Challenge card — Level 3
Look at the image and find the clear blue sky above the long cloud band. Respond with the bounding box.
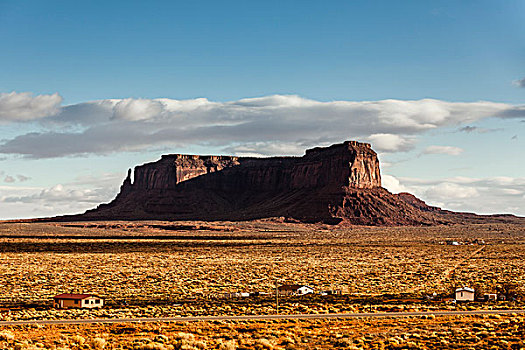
[0,0,525,103]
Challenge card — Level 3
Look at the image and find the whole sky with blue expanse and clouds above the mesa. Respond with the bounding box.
[0,0,525,219]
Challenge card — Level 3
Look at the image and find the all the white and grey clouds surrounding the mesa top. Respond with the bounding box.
[0,92,525,218]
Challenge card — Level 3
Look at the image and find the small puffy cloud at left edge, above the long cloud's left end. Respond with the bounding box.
[0,91,62,122]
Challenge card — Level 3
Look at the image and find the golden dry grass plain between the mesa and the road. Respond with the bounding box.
[0,221,525,319]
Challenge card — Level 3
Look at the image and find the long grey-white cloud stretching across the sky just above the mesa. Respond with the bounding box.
[0,95,525,158]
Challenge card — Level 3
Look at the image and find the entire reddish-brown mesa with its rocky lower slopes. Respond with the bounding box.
[71,141,516,225]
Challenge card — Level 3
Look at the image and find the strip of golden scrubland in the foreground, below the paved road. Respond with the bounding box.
[0,315,525,350]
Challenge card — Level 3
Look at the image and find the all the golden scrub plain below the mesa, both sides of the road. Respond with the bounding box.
[0,220,525,349]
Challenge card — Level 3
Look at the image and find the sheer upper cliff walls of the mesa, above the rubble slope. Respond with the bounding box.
[127,141,381,191]
